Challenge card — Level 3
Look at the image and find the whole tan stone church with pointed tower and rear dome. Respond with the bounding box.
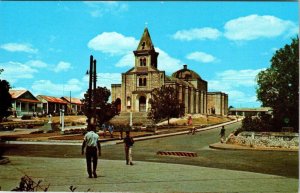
[111,28,228,115]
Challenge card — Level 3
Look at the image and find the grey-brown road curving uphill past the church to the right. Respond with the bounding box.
[1,122,299,178]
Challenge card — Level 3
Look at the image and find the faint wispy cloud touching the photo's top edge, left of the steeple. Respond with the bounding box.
[84,1,128,18]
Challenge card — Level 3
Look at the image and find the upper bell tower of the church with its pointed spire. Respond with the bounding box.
[133,28,158,69]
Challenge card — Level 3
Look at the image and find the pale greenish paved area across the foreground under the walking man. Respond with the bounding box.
[0,156,298,193]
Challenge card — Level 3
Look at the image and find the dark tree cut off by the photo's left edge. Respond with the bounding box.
[0,69,12,122]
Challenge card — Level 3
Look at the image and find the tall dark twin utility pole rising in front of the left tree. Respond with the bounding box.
[86,55,97,129]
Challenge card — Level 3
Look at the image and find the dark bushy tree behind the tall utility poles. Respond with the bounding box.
[81,87,117,125]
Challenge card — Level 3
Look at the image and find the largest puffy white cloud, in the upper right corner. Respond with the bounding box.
[224,15,298,40]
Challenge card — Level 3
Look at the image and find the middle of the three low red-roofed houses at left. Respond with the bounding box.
[37,95,68,115]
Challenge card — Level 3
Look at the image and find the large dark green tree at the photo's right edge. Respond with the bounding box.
[256,37,299,131]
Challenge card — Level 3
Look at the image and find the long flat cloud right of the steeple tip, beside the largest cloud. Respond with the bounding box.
[172,27,222,41]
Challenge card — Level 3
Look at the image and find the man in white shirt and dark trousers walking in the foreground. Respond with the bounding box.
[81,125,101,178]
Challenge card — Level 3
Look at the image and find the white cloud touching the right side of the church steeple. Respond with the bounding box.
[155,48,184,74]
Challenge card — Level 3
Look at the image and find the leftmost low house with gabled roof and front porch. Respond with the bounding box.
[9,89,42,117]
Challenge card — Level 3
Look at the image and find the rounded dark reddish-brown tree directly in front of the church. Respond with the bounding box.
[148,86,184,125]
